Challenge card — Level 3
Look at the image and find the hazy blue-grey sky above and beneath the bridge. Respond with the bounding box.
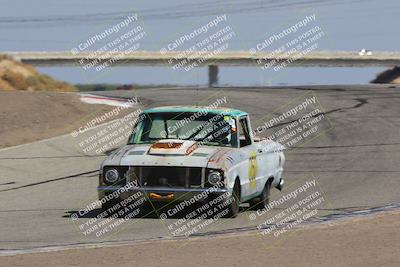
[0,0,400,85]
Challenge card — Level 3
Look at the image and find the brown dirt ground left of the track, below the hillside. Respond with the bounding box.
[0,91,113,148]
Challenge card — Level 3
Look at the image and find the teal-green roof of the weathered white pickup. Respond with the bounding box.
[143,106,247,117]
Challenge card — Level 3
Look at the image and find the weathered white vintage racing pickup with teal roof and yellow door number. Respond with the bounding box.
[97,106,285,217]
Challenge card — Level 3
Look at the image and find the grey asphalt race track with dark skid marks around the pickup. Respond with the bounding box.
[0,85,400,252]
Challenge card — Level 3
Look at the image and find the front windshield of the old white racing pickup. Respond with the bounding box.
[128,112,237,147]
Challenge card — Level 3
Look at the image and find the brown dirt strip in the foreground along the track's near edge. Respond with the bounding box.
[0,212,400,267]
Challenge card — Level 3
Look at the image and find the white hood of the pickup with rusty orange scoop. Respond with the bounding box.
[103,140,232,168]
